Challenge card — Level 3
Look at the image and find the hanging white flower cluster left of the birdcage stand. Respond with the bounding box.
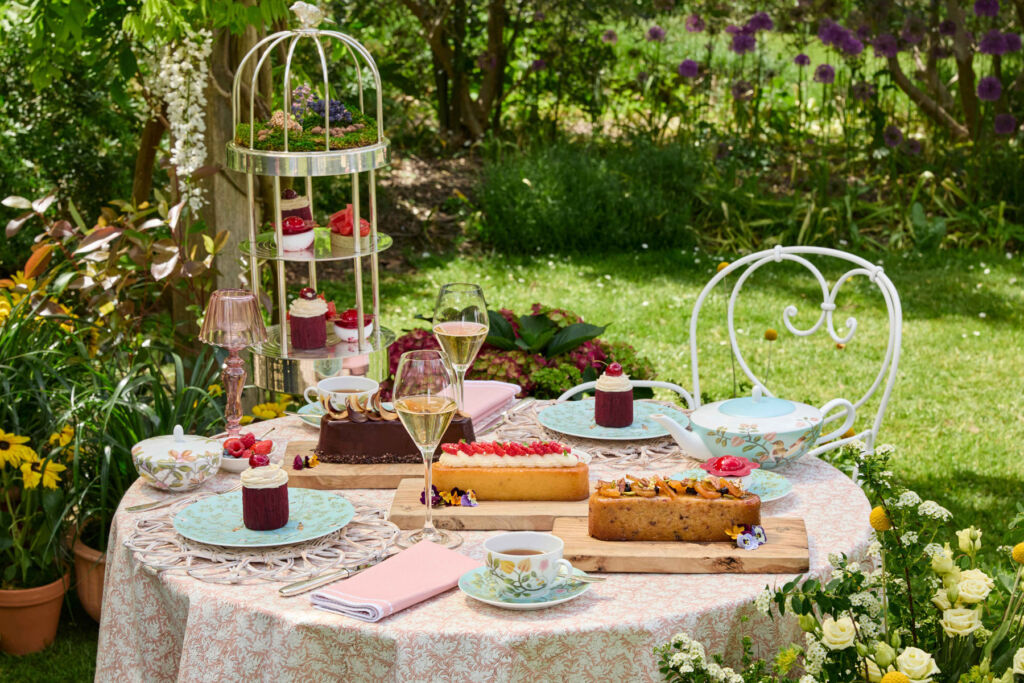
[150,30,213,213]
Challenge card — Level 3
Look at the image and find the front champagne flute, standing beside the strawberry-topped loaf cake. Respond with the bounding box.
[393,350,462,548]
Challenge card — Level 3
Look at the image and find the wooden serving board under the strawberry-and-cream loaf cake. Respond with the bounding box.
[388,477,589,531]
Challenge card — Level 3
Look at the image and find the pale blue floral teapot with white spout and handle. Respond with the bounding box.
[650,385,856,469]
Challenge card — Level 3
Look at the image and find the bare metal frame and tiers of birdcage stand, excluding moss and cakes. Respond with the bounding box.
[227,17,394,394]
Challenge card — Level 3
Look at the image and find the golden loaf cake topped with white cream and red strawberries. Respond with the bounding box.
[433,441,590,501]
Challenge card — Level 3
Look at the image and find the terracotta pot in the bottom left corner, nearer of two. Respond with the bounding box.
[0,573,71,654]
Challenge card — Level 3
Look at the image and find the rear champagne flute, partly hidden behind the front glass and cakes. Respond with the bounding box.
[434,283,490,413]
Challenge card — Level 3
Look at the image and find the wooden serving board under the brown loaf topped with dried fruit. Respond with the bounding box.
[551,517,810,573]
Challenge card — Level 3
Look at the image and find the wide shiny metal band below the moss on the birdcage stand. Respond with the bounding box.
[227,137,391,178]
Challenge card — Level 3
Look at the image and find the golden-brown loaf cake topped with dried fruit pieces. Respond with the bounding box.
[590,476,761,541]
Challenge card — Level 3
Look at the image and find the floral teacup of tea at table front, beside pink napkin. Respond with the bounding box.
[483,531,572,598]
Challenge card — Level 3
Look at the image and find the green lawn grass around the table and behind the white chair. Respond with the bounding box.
[9,250,1024,681]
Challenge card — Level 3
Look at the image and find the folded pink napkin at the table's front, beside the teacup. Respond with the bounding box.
[312,541,482,622]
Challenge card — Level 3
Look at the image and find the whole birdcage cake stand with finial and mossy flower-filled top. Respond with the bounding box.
[227,3,394,394]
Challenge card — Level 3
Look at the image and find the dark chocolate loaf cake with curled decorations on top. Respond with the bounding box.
[315,393,475,465]
